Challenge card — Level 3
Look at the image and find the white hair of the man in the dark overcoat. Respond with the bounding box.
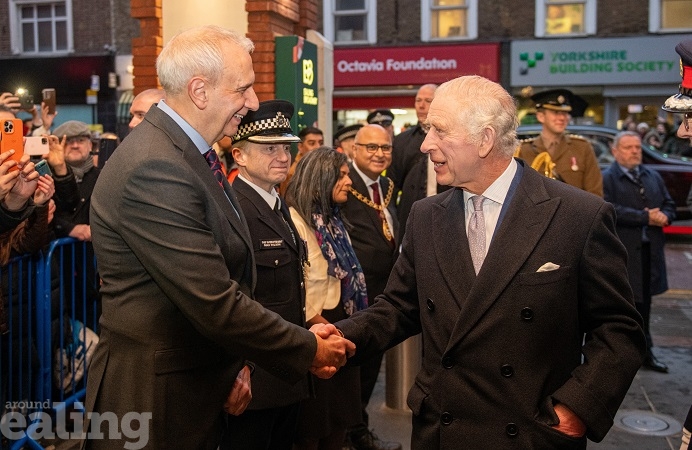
[435,75,519,157]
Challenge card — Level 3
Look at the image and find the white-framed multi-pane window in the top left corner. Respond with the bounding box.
[10,0,72,55]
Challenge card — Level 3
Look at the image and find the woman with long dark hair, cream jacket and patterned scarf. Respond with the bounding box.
[286,147,368,450]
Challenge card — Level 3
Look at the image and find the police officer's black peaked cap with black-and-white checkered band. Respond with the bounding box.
[233,100,300,144]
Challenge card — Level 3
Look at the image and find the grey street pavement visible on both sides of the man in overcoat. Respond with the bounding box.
[368,235,692,450]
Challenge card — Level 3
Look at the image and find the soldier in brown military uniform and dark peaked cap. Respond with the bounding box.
[517,89,603,197]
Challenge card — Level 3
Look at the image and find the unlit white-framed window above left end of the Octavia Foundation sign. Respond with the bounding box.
[323,0,377,44]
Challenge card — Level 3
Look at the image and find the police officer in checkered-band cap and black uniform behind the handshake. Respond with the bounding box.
[220,100,309,450]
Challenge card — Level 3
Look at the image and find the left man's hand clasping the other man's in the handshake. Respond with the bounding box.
[310,324,356,379]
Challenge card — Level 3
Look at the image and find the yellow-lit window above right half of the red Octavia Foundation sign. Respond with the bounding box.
[421,0,478,42]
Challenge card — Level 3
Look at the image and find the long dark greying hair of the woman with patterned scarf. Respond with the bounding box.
[286,146,348,226]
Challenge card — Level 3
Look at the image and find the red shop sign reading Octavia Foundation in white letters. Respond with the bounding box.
[334,44,500,87]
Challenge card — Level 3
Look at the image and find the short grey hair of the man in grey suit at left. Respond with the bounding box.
[156,25,255,95]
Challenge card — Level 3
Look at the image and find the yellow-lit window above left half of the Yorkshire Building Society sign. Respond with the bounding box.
[536,0,596,37]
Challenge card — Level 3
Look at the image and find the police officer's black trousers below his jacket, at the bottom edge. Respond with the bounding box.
[219,403,300,450]
